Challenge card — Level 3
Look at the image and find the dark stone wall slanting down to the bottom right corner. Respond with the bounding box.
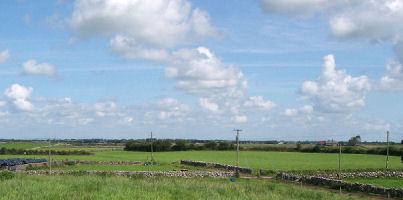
[277,172,403,198]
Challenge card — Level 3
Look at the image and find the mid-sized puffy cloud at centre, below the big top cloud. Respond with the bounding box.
[165,47,247,96]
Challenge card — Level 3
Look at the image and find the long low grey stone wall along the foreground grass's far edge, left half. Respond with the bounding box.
[25,170,235,178]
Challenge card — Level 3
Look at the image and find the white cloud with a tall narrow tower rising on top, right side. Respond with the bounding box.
[300,55,371,112]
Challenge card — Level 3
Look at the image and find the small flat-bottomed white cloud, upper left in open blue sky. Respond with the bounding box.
[21,59,56,77]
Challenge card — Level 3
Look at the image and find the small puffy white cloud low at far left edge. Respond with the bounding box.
[4,84,34,111]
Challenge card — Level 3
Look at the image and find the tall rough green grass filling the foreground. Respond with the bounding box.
[0,174,366,200]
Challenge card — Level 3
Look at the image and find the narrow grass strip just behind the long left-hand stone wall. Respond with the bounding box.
[53,164,221,171]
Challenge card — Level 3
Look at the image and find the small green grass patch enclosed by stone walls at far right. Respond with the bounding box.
[343,177,403,188]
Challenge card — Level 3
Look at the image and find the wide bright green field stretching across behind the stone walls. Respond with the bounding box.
[0,151,403,170]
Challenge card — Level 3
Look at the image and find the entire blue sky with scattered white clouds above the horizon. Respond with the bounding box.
[0,0,403,141]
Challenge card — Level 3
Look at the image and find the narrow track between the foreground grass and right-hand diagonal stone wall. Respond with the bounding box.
[241,176,393,199]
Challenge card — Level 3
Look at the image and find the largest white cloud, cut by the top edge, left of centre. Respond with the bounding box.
[69,0,218,59]
